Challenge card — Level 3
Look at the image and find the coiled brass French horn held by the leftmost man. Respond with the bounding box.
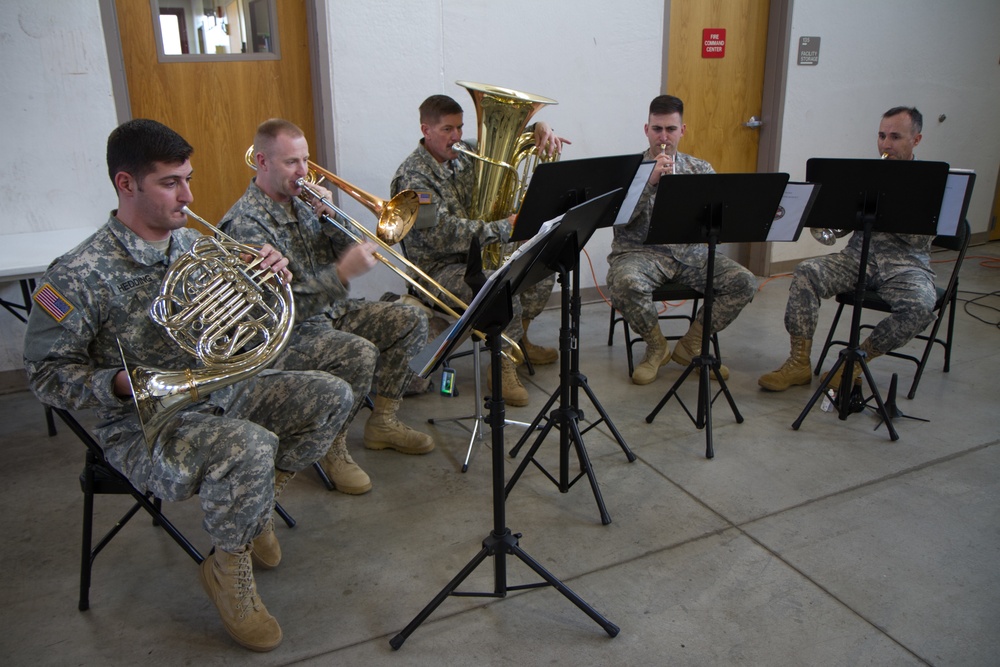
[118,207,295,447]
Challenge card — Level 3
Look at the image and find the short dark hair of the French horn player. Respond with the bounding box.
[107,118,194,192]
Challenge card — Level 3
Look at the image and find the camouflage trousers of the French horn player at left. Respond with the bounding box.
[104,370,350,551]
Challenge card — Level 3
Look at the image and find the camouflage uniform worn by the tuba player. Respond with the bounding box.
[391,140,555,348]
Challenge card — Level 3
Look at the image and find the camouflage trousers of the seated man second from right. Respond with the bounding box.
[607,253,757,335]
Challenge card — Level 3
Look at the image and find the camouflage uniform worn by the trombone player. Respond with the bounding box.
[221,181,427,424]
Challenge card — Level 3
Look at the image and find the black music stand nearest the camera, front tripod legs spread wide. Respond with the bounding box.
[389,215,620,649]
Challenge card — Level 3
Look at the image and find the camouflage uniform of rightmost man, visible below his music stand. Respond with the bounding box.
[785,232,937,354]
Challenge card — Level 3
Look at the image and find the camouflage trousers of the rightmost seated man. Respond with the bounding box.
[785,252,937,354]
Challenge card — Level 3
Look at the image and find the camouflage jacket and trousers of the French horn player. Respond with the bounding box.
[24,214,352,551]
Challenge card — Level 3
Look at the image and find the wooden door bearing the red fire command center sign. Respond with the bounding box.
[663,0,770,173]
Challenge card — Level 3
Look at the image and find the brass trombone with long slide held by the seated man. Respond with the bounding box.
[244,145,524,364]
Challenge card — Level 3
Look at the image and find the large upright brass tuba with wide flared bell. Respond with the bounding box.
[452,81,559,269]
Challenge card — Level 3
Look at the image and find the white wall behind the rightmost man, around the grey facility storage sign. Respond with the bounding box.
[771,0,1000,261]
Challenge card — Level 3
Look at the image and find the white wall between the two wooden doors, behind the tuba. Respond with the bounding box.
[321,0,664,298]
